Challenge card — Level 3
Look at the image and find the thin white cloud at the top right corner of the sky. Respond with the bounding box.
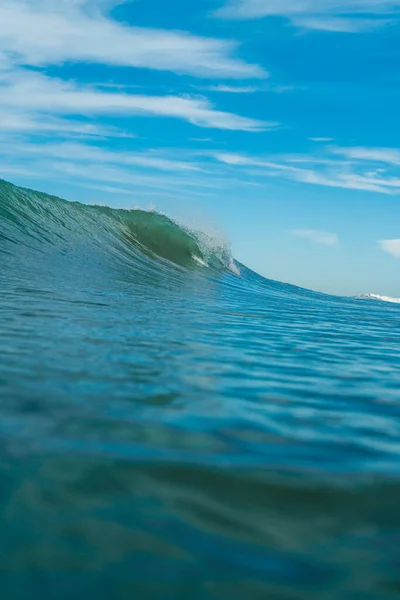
[218,0,400,32]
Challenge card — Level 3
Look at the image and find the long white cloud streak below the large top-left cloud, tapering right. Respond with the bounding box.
[0,69,268,131]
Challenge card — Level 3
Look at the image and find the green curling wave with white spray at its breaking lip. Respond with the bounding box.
[0,180,238,273]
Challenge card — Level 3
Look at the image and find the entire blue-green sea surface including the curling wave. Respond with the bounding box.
[0,182,400,600]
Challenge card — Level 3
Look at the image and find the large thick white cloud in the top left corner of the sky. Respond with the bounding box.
[0,0,265,79]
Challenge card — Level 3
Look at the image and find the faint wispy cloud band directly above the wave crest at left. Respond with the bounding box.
[0,138,260,204]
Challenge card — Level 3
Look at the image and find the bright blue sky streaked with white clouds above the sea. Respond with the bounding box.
[0,0,400,297]
